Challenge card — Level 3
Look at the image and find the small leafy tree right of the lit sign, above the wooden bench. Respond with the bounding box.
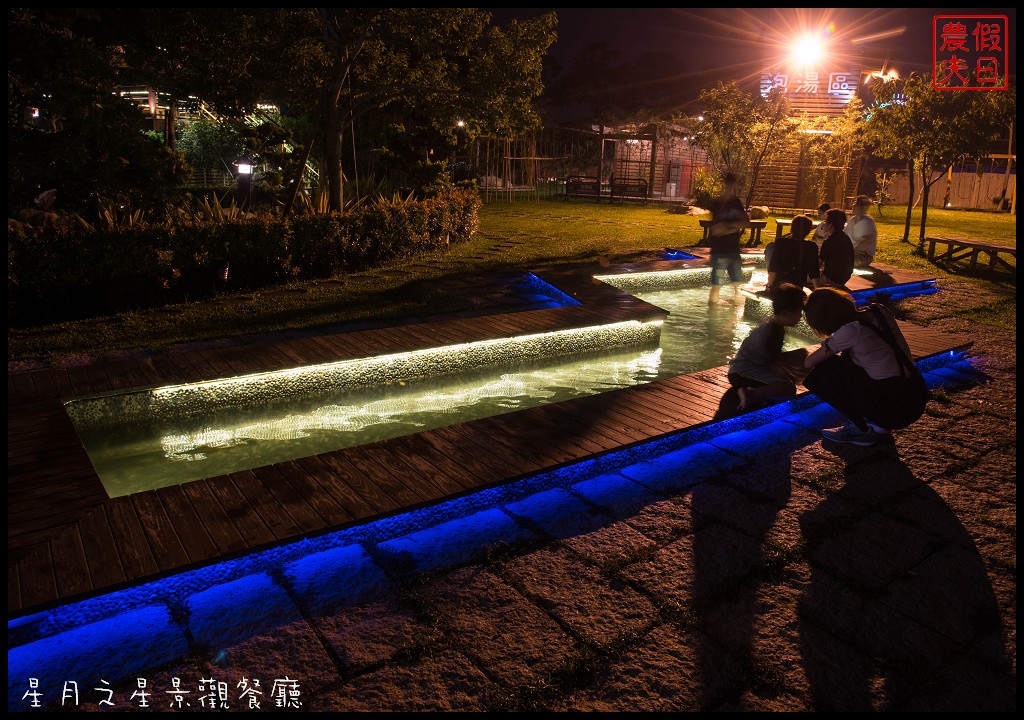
[867,75,1017,246]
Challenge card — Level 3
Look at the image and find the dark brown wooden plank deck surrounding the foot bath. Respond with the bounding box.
[7,260,970,618]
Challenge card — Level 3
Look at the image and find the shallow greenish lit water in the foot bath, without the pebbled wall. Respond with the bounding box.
[68,270,814,497]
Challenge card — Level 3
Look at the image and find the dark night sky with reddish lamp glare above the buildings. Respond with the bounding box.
[483,7,1017,79]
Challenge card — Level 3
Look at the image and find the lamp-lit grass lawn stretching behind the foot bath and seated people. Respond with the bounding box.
[7,200,1017,363]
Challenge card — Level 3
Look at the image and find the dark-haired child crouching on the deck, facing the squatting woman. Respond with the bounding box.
[729,283,805,410]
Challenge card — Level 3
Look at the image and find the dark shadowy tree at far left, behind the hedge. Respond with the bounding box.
[7,8,186,212]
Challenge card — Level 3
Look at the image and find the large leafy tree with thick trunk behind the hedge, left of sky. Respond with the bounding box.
[272,8,556,217]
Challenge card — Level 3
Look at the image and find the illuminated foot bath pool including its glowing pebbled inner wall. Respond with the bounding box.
[66,268,814,497]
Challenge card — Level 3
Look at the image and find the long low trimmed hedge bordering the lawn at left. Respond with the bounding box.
[7,188,481,327]
